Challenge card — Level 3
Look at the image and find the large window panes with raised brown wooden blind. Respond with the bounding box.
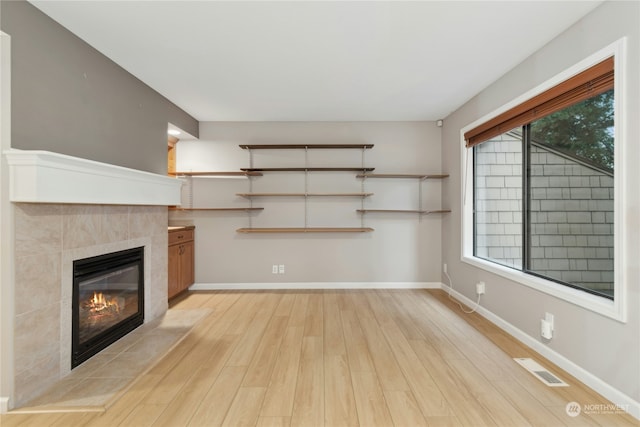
[464,57,616,310]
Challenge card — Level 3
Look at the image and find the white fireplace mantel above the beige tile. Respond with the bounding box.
[4,149,182,206]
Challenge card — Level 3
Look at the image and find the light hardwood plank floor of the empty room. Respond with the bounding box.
[0,290,639,427]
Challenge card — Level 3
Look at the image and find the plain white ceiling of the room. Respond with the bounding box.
[31,0,601,121]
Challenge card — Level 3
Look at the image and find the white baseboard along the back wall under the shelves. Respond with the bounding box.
[189,282,442,291]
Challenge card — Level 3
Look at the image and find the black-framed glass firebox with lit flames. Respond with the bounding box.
[71,247,144,369]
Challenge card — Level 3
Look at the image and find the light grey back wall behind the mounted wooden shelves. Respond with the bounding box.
[170,122,446,284]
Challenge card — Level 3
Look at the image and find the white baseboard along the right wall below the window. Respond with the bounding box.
[442,284,640,420]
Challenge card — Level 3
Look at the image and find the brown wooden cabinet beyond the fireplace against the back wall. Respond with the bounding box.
[168,226,195,298]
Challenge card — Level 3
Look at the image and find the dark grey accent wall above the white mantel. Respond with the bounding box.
[0,1,198,174]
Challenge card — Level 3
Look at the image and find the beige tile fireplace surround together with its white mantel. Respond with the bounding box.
[0,149,181,412]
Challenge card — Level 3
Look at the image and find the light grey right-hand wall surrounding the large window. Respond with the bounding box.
[442,2,640,417]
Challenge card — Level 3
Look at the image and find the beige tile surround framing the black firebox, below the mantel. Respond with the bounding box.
[13,203,167,406]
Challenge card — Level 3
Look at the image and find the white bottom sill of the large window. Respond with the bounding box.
[462,256,626,323]
